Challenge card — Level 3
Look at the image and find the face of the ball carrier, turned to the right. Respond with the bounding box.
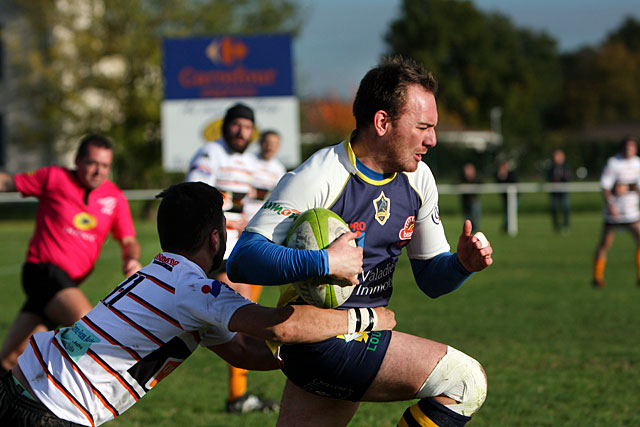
[384,85,438,173]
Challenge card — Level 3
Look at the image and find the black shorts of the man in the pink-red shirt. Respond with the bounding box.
[22,262,78,318]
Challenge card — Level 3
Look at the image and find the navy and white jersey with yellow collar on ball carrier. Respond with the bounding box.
[245,135,450,308]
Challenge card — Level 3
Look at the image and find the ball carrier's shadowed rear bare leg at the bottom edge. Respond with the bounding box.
[277,380,360,427]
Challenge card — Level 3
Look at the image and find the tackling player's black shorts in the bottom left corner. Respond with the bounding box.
[0,371,85,427]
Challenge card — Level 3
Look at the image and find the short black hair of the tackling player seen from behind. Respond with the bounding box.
[156,182,224,255]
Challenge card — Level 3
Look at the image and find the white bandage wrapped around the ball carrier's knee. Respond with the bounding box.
[416,347,487,416]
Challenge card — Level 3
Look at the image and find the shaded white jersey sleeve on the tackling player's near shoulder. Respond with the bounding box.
[176,278,254,347]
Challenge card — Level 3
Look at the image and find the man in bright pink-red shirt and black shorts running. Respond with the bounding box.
[0,135,141,370]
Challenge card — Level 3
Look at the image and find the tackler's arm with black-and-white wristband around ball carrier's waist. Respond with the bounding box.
[228,304,396,344]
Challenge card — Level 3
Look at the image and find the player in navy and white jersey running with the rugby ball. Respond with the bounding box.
[227,58,493,426]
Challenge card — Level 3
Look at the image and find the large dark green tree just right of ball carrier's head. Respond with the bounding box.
[386,0,561,143]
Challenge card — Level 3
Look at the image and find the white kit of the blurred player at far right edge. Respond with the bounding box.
[600,154,640,224]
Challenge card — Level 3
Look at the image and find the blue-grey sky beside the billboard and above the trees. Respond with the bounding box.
[294,0,640,99]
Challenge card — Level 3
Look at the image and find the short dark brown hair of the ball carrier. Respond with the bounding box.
[353,56,438,129]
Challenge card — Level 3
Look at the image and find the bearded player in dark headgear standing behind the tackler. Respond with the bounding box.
[186,103,278,413]
